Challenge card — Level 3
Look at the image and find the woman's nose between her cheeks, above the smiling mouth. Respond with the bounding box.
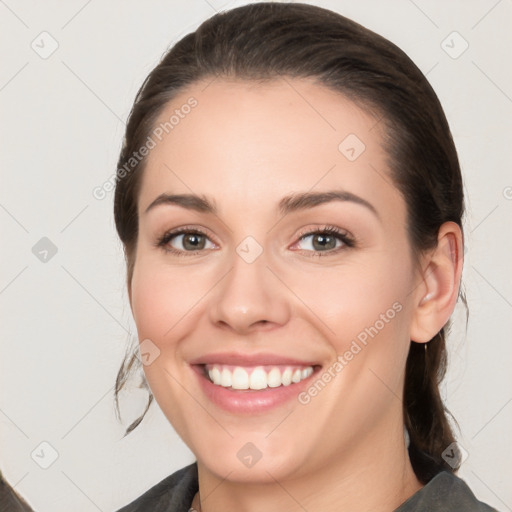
[210,248,290,334]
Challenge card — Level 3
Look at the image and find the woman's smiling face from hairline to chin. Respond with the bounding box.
[130,78,419,481]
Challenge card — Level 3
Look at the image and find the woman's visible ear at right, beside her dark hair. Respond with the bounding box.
[410,222,464,343]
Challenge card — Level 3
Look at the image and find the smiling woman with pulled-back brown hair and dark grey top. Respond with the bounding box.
[111,3,491,512]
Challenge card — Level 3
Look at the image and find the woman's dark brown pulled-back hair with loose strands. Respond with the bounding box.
[114,2,464,483]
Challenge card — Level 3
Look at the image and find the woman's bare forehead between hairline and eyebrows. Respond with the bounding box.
[139,78,400,220]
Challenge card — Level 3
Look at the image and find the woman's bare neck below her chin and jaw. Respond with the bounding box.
[194,427,422,512]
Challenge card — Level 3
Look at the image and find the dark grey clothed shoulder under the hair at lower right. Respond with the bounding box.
[395,471,496,512]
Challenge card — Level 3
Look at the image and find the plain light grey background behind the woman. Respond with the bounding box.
[0,0,512,512]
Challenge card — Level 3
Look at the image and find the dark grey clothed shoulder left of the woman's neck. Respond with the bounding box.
[117,462,198,512]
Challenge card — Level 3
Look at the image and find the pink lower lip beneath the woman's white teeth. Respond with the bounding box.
[193,365,317,414]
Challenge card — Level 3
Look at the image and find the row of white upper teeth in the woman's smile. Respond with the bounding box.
[207,364,313,390]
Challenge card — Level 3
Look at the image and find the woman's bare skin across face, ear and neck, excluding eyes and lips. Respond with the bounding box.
[129,78,462,512]
